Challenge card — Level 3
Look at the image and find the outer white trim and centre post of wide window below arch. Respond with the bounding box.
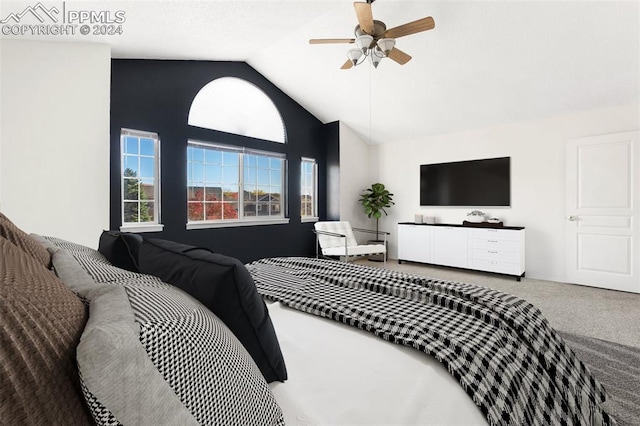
[186,139,289,226]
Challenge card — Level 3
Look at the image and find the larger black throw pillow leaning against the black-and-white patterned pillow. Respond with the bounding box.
[139,239,287,382]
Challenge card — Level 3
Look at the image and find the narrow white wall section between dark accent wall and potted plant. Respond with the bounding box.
[340,123,375,235]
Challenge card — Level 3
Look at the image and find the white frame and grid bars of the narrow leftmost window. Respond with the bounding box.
[120,128,164,232]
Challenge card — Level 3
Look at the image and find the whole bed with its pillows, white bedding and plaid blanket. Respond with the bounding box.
[0,214,615,425]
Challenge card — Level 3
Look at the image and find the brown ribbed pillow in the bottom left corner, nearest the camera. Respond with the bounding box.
[0,237,92,425]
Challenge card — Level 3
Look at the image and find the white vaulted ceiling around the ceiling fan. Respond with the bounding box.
[0,0,640,143]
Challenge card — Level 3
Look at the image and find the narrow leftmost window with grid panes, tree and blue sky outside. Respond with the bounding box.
[120,129,162,232]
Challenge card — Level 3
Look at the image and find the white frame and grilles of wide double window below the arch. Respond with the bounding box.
[186,139,289,230]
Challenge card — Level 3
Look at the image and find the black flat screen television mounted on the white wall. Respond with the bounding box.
[420,157,511,207]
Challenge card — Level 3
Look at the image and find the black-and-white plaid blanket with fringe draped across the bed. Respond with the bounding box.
[247,257,616,425]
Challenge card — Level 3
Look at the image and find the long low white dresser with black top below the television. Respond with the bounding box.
[398,222,525,281]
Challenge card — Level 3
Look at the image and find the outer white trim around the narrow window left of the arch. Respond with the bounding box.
[120,128,164,232]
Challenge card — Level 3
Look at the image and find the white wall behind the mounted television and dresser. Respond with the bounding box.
[372,104,640,281]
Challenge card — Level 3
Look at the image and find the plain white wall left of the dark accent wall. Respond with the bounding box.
[0,40,111,247]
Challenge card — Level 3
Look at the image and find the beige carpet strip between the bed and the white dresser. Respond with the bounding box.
[356,259,640,348]
